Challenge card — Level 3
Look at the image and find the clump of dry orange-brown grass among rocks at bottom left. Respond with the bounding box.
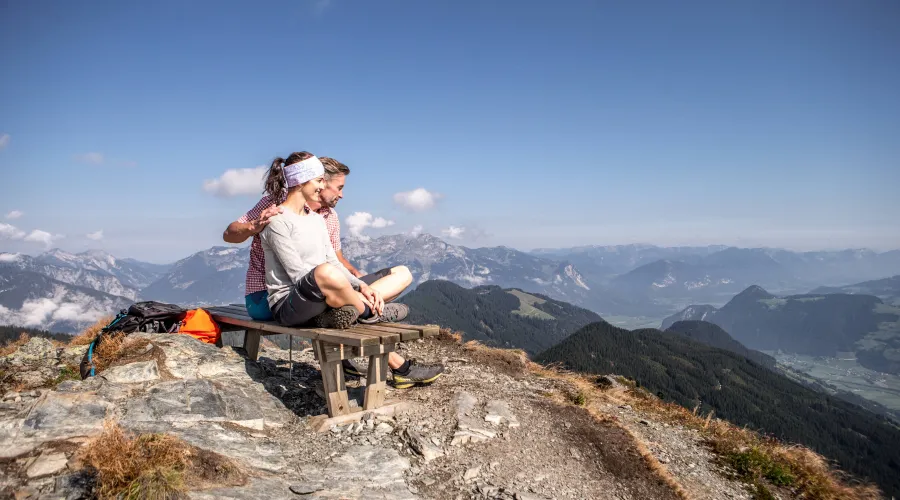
[80,422,246,500]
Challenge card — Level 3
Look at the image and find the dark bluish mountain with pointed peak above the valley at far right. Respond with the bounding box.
[661,286,900,374]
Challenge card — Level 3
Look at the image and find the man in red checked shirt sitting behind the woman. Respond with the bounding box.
[222,157,444,389]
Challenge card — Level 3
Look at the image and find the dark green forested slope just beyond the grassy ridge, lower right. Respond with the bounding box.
[536,321,900,492]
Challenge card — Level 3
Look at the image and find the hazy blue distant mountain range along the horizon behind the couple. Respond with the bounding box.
[0,234,900,332]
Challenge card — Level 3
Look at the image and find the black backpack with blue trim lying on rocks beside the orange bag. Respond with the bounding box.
[81,300,187,380]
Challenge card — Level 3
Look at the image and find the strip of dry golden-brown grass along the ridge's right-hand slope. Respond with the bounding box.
[465,342,883,500]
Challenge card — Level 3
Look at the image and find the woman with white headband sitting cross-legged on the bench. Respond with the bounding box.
[259,151,408,328]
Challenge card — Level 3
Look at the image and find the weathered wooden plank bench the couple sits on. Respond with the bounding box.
[205,304,439,417]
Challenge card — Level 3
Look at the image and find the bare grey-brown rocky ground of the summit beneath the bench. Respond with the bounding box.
[0,335,749,500]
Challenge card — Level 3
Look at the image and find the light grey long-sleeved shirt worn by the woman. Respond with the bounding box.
[259,208,362,309]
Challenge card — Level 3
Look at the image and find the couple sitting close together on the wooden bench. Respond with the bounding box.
[223,151,443,389]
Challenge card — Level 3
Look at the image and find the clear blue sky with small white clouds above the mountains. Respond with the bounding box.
[0,0,900,263]
